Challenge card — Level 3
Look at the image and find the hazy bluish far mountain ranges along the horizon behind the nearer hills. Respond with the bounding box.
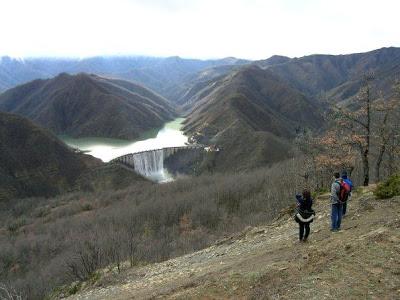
[0,47,400,102]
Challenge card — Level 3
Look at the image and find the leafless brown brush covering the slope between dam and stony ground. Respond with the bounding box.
[0,161,312,299]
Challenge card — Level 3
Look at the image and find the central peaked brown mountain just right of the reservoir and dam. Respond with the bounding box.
[185,66,322,169]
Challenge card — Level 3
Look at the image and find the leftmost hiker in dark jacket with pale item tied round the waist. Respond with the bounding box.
[295,189,315,242]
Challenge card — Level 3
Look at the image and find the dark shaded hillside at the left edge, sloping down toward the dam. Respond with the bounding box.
[0,112,145,202]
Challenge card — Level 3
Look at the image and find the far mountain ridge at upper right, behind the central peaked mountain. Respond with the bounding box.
[255,47,400,101]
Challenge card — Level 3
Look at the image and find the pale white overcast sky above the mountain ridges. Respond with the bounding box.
[0,0,400,59]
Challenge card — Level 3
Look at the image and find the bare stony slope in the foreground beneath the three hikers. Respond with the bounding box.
[61,187,400,299]
